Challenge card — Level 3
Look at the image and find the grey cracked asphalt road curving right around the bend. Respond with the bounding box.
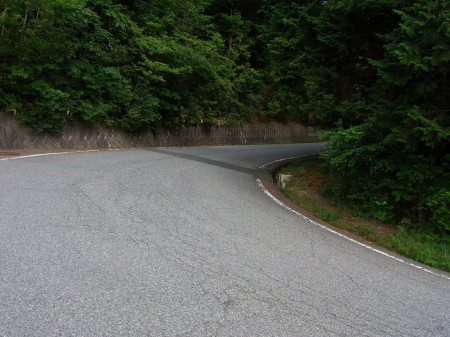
[0,144,450,337]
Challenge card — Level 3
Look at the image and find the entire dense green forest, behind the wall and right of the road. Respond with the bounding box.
[0,0,450,234]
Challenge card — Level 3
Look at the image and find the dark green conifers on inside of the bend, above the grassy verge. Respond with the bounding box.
[323,1,450,233]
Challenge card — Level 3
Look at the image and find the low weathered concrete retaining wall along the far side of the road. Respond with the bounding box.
[0,111,317,149]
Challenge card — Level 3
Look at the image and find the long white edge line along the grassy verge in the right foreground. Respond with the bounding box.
[256,179,450,280]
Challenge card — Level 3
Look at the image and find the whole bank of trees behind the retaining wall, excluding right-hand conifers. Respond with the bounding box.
[0,0,404,132]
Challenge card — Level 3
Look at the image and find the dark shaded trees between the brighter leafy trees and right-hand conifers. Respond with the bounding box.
[260,0,396,128]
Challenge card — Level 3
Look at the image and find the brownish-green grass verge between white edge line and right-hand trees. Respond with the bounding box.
[280,159,450,271]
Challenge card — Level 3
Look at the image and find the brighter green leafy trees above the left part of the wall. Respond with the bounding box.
[0,0,266,133]
